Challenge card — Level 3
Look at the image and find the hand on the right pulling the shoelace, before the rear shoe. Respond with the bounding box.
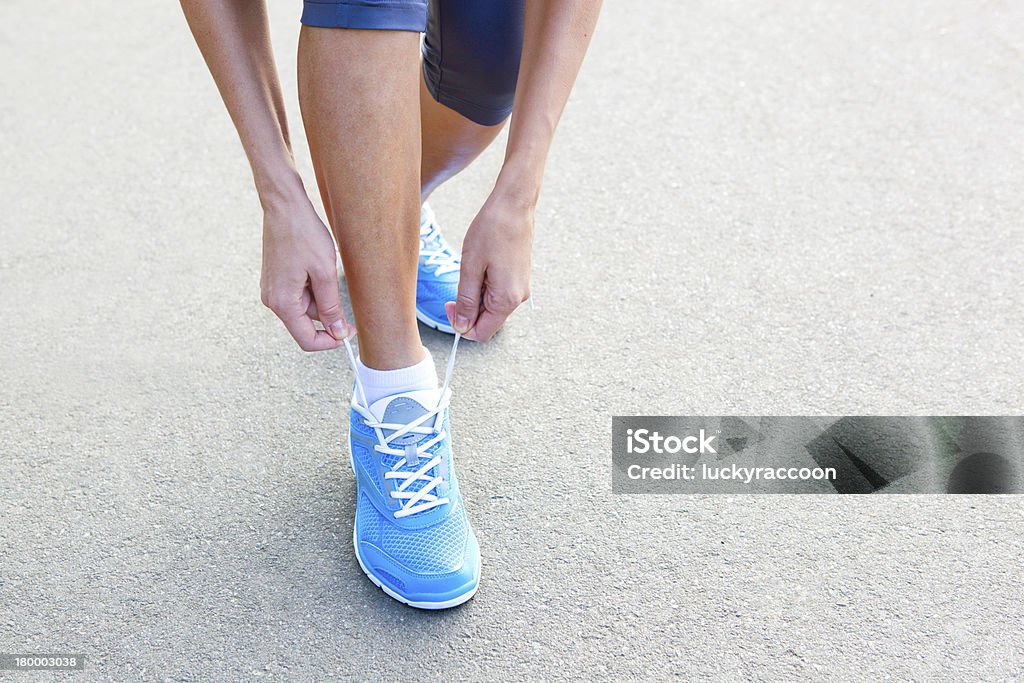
[445,187,535,342]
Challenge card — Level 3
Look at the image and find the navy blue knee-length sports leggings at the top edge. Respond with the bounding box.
[302,0,525,126]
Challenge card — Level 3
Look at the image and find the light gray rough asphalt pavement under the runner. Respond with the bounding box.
[0,0,1024,681]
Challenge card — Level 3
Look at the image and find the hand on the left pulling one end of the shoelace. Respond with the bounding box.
[260,194,355,351]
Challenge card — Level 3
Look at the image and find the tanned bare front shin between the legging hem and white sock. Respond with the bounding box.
[299,27,423,370]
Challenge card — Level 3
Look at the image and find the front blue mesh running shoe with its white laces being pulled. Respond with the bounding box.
[345,335,480,609]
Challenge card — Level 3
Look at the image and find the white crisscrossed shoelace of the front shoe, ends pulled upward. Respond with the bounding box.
[345,333,462,518]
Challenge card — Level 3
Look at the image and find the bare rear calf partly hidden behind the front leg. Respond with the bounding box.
[420,79,505,202]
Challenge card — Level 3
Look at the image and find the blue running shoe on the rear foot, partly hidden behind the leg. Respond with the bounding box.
[416,204,459,335]
